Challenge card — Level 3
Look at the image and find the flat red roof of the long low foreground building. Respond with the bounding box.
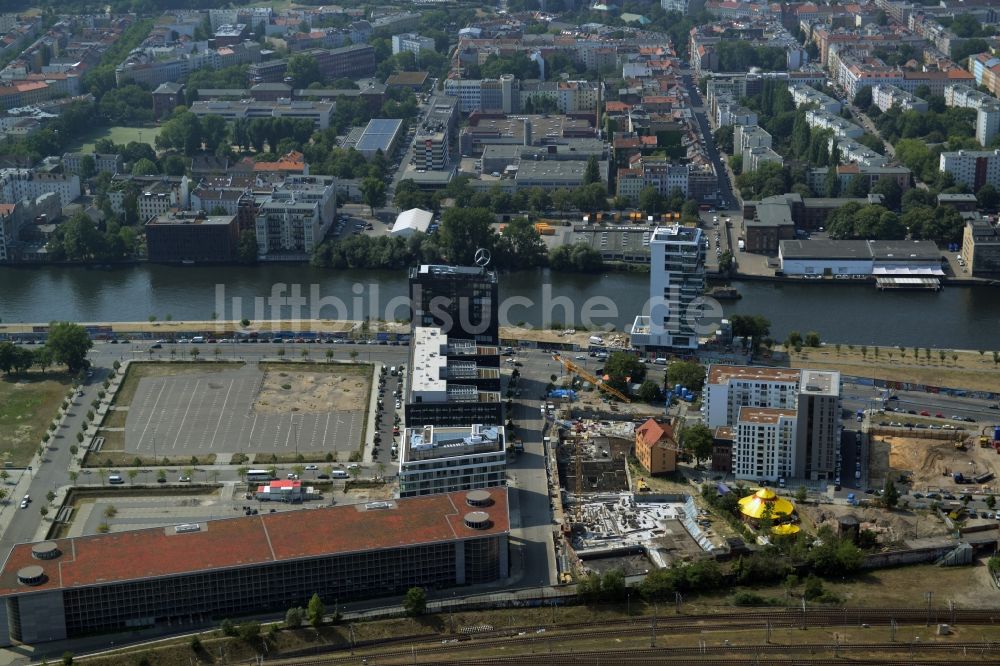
[0,487,510,596]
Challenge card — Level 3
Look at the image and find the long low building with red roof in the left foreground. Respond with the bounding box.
[0,487,510,645]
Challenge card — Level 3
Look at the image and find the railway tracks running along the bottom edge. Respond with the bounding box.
[268,608,1000,665]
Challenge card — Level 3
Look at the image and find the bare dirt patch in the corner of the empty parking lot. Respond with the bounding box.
[254,366,371,414]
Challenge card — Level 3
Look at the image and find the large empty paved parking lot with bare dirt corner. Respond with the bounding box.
[125,364,371,457]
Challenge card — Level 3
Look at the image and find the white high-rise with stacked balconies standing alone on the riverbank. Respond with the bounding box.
[632,225,705,349]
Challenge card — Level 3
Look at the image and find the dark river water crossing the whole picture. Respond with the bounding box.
[0,264,1000,351]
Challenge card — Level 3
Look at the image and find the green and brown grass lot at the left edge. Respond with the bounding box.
[0,372,70,466]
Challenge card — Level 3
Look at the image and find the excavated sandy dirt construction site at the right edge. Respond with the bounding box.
[869,436,1000,490]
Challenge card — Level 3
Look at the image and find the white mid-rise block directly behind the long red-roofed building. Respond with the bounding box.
[399,423,507,497]
